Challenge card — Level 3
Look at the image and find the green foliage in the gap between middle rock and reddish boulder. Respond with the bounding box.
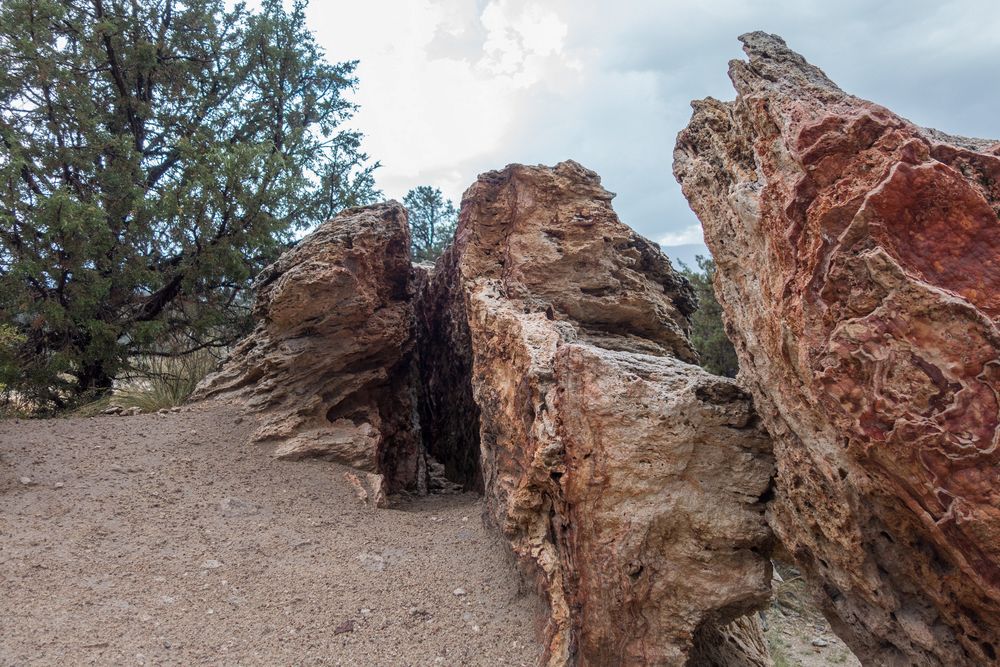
[681,255,740,377]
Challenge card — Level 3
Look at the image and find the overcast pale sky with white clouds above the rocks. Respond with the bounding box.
[308,0,1000,266]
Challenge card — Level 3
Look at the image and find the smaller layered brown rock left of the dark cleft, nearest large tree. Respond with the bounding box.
[195,202,426,493]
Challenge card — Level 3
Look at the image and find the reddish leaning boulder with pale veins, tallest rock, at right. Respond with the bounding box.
[675,33,1000,665]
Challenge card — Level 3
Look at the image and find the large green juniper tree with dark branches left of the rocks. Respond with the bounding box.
[0,0,378,407]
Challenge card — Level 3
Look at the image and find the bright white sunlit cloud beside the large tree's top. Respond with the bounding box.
[308,0,573,206]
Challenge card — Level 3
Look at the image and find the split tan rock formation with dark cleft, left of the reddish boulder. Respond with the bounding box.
[198,162,774,667]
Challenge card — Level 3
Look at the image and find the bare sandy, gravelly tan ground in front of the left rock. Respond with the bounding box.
[0,407,538,666]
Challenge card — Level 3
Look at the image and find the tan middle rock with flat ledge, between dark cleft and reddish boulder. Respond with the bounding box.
[421,162,773,665]
